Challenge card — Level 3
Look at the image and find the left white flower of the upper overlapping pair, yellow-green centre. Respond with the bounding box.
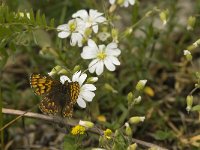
[57,18,86,47]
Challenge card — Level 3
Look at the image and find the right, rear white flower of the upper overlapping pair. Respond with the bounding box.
[72,9,106,33]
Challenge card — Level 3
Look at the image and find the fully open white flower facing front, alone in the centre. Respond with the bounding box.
[81,39,121,75]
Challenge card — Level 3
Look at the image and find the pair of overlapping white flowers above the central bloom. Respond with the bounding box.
[57,9,106,47]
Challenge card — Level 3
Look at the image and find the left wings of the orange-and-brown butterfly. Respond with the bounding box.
[30,74,62,115]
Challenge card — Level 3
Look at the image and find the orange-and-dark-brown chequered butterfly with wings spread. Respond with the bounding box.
[30,74,80,117]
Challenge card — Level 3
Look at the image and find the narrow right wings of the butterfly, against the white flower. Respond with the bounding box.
[62,82,80,117]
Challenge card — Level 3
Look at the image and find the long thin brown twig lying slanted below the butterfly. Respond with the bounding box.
[1,108,168,150]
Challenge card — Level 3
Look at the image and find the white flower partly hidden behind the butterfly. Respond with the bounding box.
[60,71,96,108]
